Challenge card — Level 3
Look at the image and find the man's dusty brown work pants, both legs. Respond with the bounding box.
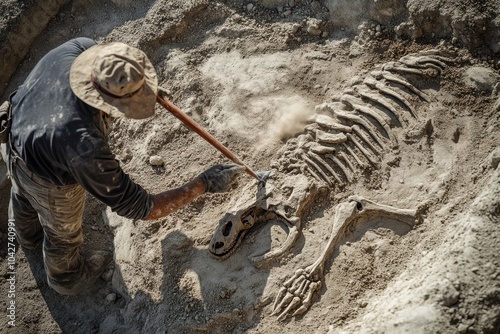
[2,142,85,294]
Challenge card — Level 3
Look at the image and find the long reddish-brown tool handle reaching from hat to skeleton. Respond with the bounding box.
[156,93,265,182]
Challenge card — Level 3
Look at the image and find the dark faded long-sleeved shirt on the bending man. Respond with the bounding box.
[11,38,153,219]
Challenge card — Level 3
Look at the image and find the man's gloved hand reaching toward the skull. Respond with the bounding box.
[198,165,245,193]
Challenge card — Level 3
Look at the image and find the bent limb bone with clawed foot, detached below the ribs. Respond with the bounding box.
[273,196,419,320]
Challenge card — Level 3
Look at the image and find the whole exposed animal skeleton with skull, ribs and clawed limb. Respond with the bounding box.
[209,50,454,319]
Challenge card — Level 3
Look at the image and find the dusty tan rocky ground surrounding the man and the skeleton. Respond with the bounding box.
[0,0,500,333]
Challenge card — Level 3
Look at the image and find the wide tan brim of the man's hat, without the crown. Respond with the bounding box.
[69,43,158,119]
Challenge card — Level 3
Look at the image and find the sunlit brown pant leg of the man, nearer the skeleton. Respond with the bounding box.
[12,162,85,294]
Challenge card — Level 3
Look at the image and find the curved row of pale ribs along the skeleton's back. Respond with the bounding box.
[273,50,452,188]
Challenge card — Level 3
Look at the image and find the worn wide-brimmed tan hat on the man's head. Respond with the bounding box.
[69,43,158,119]
